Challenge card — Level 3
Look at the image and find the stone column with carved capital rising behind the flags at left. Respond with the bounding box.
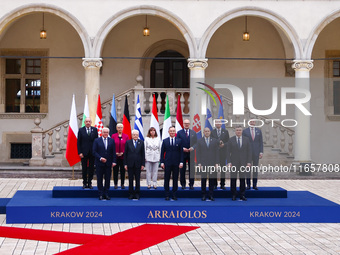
[83,58,102,125]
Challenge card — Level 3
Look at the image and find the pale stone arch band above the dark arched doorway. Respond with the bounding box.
[93,6,197,56]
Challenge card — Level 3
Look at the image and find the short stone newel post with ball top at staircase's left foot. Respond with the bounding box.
[29,118,45,166]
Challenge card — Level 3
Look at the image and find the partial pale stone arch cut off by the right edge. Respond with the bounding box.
[304,9,340,59]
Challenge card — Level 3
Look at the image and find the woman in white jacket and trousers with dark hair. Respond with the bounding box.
[144,127,162,189]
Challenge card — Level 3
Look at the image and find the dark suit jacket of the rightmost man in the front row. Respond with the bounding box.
[227,136,252,166]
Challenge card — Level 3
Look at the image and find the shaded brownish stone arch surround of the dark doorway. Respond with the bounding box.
[139,39,189,85]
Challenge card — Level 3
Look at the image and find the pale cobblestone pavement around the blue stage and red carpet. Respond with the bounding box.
[0,178,340,255]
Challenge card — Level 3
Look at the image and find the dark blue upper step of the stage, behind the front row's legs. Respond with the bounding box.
[52,186,287,198]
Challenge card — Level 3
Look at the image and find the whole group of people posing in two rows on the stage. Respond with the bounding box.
[78,118,263,201]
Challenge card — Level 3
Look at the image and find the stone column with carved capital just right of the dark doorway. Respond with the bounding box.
[188,58,208,127]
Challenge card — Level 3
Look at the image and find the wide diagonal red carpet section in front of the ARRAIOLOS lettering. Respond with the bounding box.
[58,224,199,255]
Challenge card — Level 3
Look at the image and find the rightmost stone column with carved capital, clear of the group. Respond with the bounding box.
[292,60,313,163]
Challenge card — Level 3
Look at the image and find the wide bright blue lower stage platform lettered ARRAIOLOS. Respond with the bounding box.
[6,191,340,224]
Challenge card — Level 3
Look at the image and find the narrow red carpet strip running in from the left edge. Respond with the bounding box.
[0,226,103,244]
